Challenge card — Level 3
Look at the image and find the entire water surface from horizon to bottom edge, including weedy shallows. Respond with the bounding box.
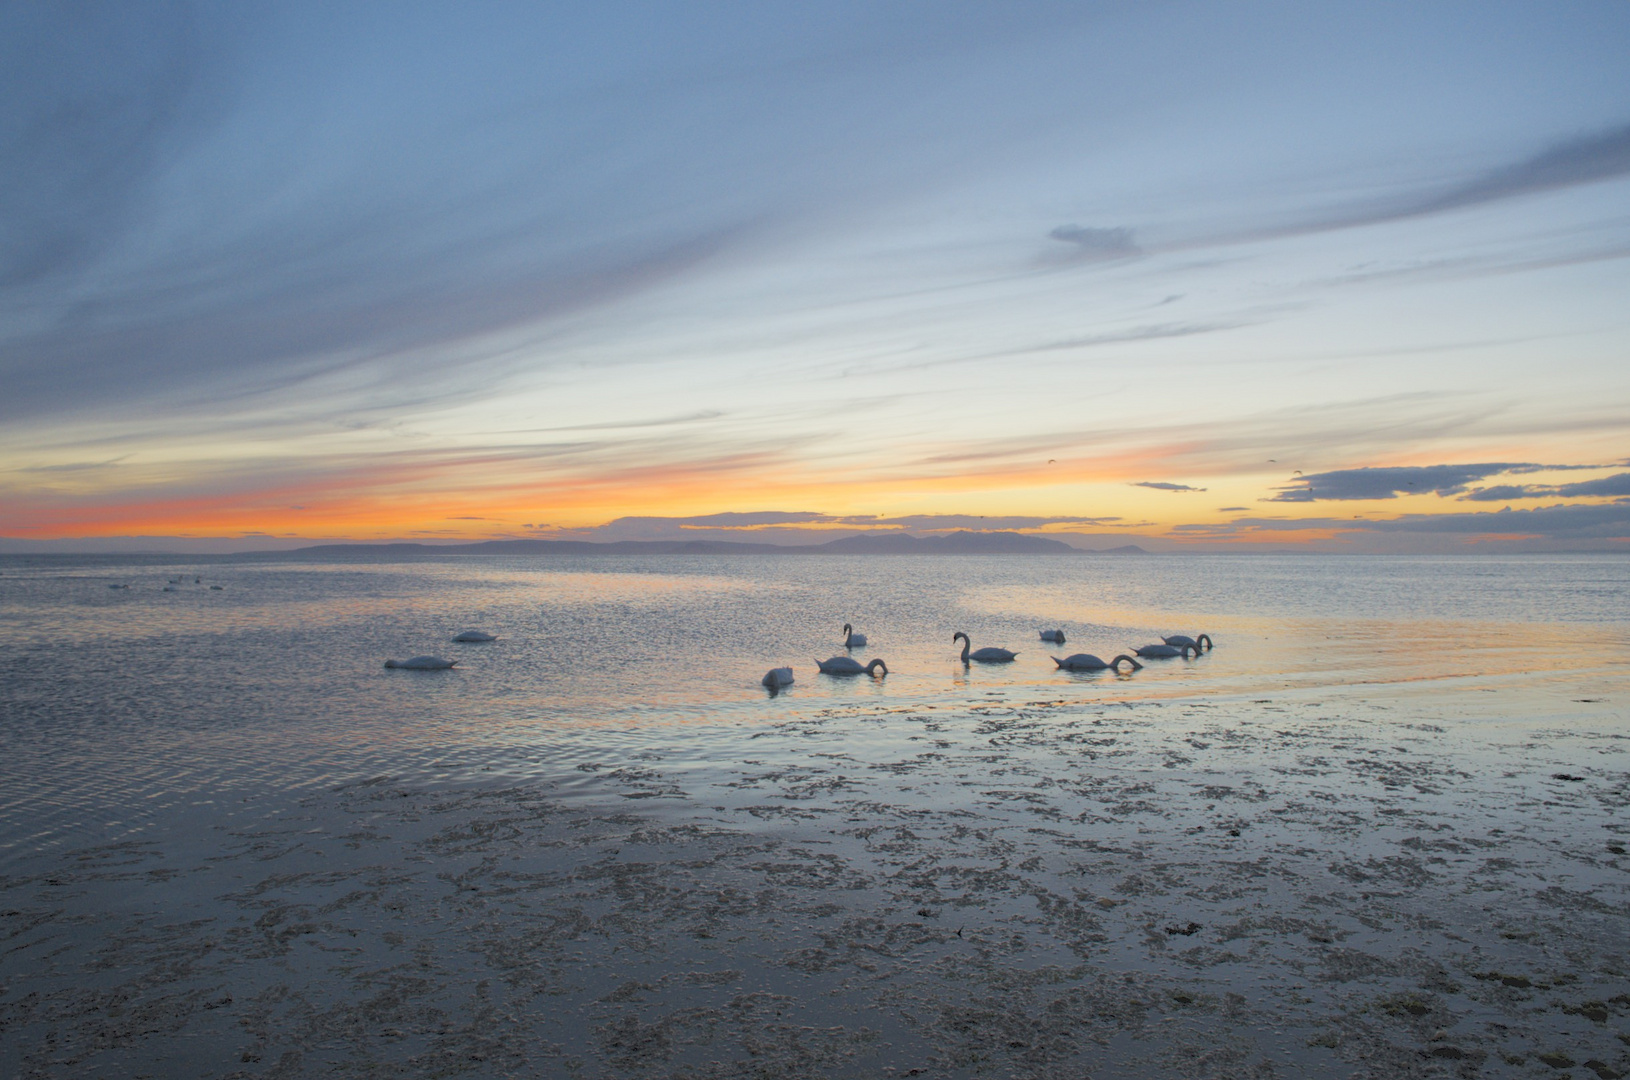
[0,557,1630,1080]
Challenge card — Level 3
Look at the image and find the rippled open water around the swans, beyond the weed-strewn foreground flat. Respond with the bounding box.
[0,555,1630,854]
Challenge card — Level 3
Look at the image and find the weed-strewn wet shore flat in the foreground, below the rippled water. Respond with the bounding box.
[0,684,1630,1080]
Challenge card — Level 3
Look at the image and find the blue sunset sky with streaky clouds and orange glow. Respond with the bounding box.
[0,0,1630,552]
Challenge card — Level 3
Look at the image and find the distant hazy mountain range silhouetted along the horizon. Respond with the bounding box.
[253,531,1148,559]
